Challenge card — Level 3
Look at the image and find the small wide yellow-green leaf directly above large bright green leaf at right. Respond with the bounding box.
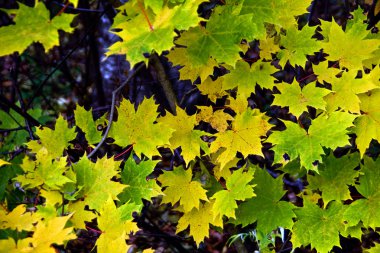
[273,81,331,117]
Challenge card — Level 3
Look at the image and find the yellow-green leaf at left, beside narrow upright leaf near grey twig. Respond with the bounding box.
[27,116,76,159]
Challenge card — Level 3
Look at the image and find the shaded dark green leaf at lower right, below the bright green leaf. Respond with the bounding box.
[307,152,360,207]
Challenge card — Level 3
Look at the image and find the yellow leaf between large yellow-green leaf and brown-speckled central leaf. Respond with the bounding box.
[157,107,209,164]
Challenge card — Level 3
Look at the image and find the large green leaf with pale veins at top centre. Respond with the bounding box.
[176,6,256,67]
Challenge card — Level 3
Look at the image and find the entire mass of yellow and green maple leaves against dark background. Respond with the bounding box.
[0,0,380,252]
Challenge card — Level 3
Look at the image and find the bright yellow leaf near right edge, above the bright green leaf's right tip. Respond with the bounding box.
[325,68,380,113]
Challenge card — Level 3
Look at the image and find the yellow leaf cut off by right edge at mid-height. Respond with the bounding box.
[352,89,380,157]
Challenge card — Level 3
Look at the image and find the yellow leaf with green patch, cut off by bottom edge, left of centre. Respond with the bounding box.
[96,196,138,253]
